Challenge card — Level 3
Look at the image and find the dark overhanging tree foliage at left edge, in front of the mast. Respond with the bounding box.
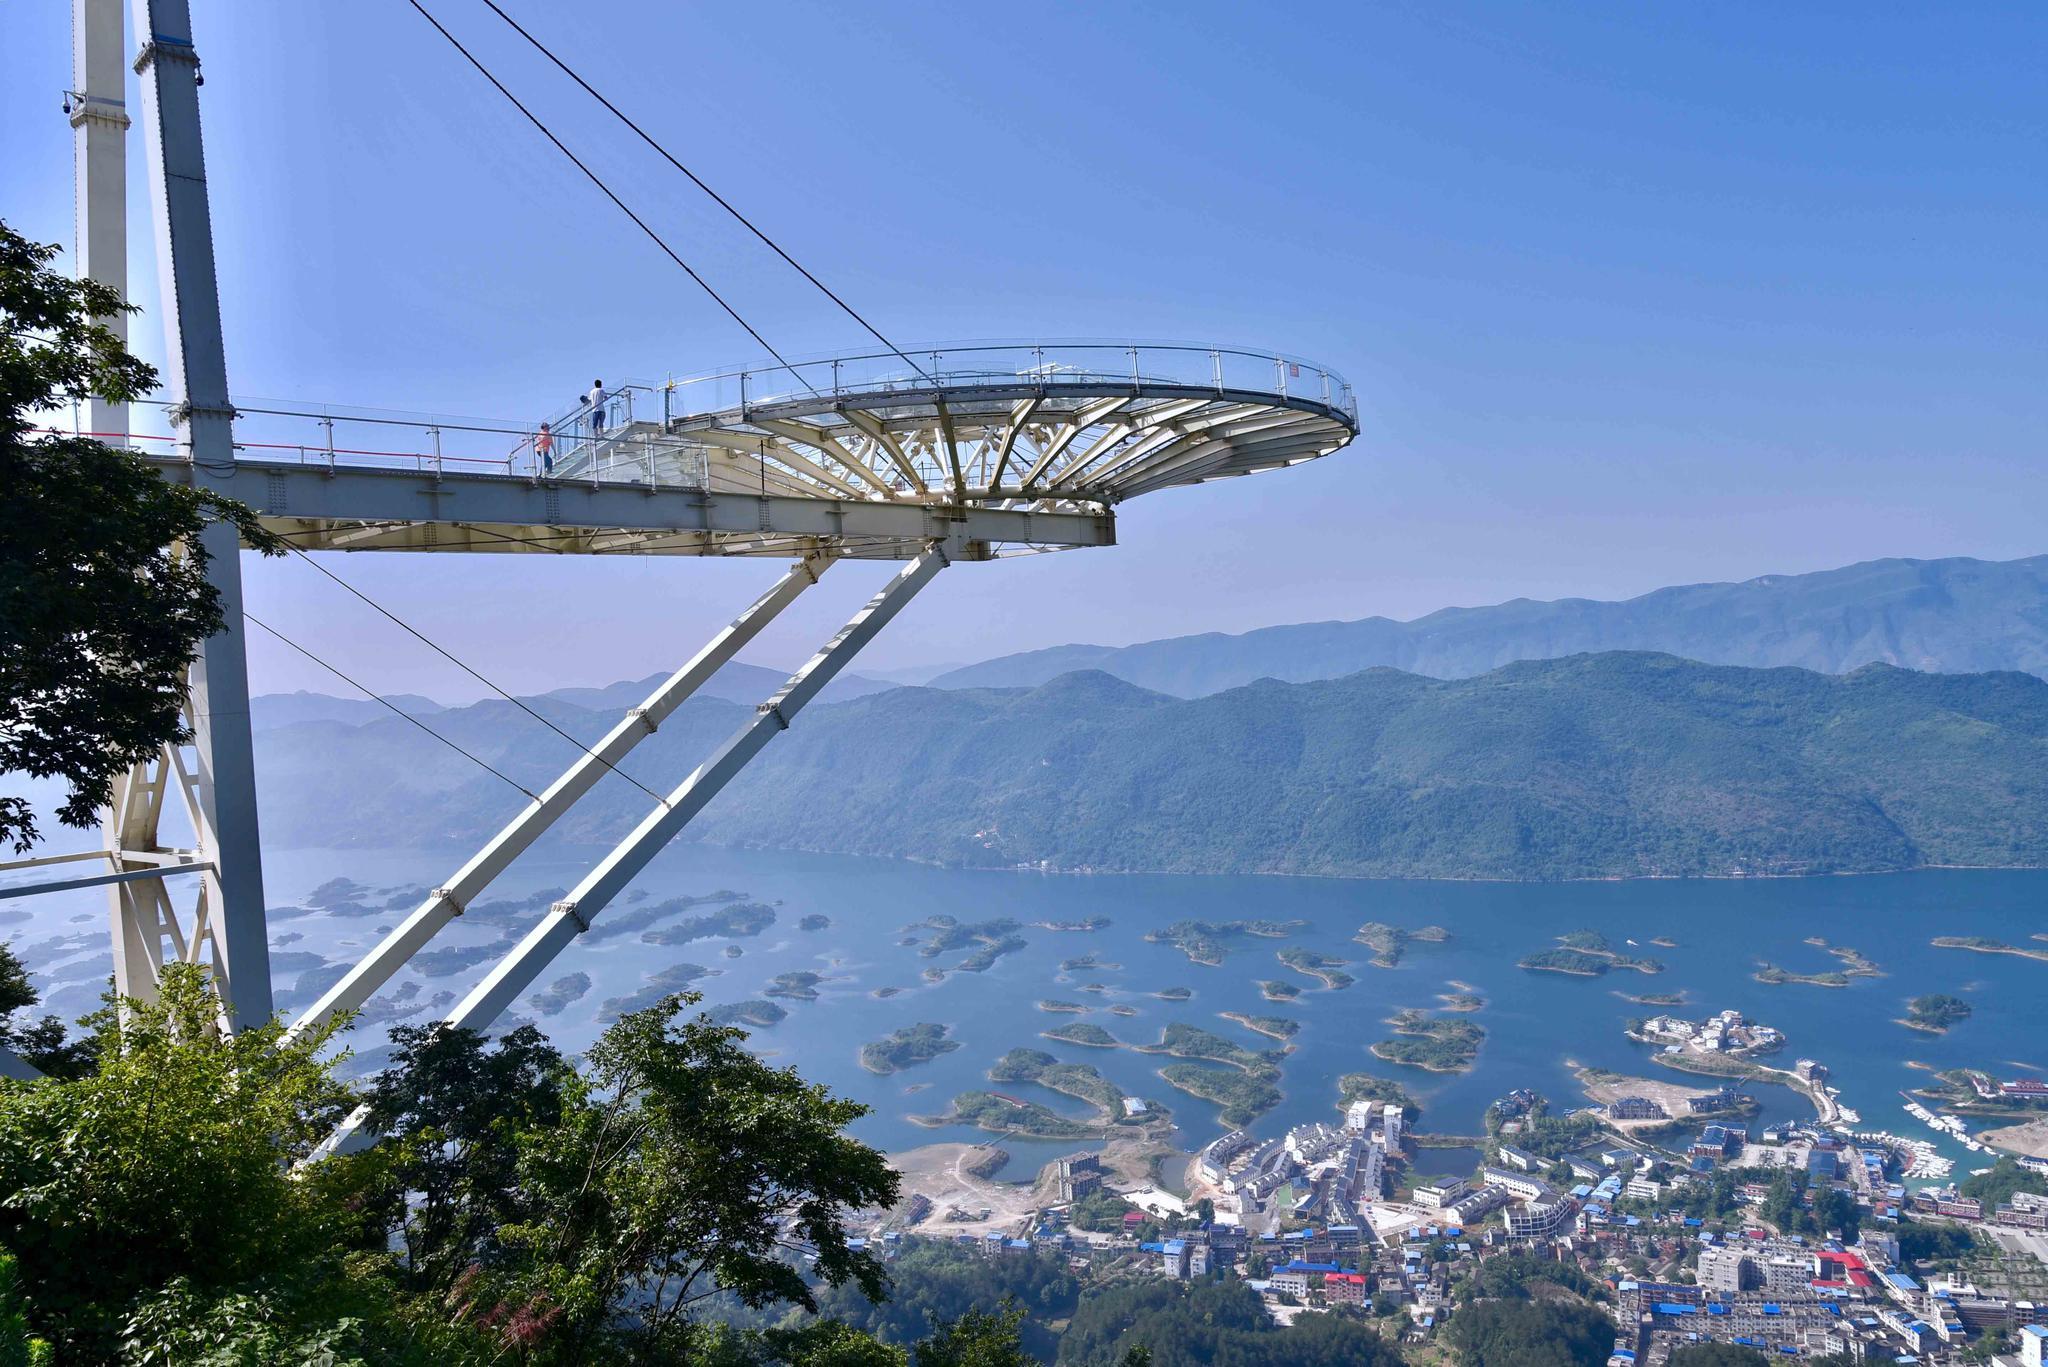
[0,223,283,853]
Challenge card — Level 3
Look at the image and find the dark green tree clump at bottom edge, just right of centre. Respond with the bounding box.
[1057,1281,1401,1367]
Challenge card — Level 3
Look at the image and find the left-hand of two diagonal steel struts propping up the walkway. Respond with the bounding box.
[287,551,836,1039]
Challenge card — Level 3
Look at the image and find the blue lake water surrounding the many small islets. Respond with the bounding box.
[0,844,2048,1168]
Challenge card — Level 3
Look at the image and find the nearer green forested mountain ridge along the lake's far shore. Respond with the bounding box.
[256,652,2048,879]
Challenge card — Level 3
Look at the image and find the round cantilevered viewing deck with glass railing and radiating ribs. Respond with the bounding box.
[551,342,1358,512]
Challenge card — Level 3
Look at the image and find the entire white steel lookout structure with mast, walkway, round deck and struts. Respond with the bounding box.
[0,0,1358,1098]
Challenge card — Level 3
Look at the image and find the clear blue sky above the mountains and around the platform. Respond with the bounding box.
[0,0,2048,699]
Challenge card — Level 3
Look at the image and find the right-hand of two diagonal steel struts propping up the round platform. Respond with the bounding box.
[446,545,948,1031]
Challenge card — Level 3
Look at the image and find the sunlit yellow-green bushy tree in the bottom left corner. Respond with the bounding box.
[0,965,346,1357]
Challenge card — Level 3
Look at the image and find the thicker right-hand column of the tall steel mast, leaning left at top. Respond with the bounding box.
[131,0,270,1029]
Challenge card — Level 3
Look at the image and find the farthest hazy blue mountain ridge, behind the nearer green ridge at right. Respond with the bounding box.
[932,555,2048,697]
